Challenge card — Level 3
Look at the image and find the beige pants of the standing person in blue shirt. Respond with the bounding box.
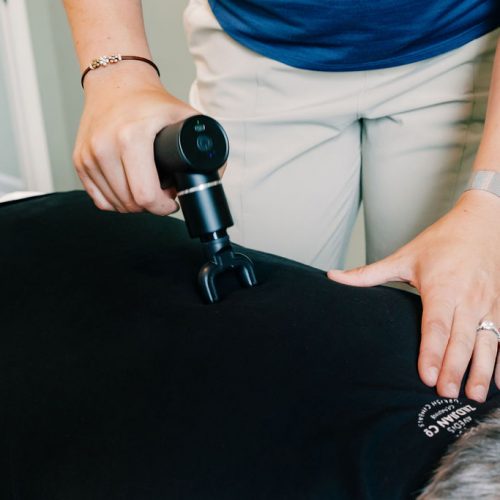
[184,0,499,269]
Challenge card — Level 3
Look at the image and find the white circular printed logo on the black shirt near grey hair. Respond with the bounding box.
[417,398,477,438]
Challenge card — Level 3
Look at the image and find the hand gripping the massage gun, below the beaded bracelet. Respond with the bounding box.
[73,61,197,215]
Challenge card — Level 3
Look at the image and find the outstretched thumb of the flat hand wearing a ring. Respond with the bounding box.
[327,257,406,286]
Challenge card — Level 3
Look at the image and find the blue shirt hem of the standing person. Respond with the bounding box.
[209,0,500,71]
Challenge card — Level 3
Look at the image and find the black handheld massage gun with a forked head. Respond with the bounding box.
[154,115,257,303]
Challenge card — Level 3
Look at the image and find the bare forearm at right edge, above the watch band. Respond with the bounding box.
[474,41,500,172]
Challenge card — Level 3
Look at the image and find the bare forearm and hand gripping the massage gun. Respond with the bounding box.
[63,0,197,215]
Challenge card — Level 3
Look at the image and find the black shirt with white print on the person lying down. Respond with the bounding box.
[0,192,500,500]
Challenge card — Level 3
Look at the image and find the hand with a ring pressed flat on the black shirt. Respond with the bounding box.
[328,191,500,401]
